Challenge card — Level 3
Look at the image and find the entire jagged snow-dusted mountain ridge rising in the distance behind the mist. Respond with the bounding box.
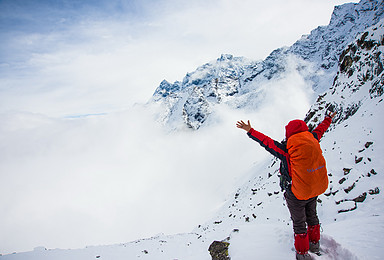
[150,0,384,130]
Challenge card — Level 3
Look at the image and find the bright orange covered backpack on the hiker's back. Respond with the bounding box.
[287,131,328,200]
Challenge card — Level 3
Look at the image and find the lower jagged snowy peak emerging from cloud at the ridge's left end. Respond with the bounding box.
[151,54,252,129]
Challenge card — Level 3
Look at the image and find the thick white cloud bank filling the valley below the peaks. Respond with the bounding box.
[0,61,312,252]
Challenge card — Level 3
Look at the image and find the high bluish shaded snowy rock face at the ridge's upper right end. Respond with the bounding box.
[288,0,384,92]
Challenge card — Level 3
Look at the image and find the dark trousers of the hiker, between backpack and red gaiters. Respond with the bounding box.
[284,189,319,234]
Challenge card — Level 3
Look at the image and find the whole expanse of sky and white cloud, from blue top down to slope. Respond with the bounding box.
[0,0,356,254]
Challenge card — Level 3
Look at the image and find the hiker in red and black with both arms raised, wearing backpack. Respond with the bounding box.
[236,113,336,260]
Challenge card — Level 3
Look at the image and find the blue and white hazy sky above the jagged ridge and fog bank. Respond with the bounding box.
[0,0,360,117]
